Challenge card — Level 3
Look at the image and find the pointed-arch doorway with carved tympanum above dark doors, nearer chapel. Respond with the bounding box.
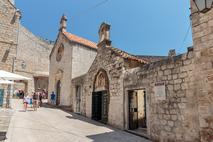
[92,69,110,123]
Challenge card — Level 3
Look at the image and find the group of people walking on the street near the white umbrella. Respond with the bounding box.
[23,92,43,111]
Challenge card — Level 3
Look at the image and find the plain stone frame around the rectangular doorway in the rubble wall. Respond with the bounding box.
[124,87,151,136]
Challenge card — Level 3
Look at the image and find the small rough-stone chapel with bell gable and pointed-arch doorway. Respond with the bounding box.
[72,23,165,129]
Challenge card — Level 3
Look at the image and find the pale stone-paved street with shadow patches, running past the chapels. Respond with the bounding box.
[6,100,151,142]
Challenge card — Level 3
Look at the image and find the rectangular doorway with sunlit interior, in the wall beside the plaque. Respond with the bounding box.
[128,90,147,131]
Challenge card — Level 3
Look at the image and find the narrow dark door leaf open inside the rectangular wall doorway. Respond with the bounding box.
[129,91,138,130]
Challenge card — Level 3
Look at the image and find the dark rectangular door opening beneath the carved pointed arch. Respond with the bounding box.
[92,91,108,124]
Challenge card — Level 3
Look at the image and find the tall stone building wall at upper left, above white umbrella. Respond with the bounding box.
[0,0,20,72]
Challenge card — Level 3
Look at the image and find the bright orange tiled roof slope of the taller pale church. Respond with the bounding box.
[63,31,97,49]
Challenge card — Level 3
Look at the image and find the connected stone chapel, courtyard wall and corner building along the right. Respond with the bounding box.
[71,1,213,142]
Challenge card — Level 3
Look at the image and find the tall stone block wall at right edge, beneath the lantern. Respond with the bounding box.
[191,1,213,142]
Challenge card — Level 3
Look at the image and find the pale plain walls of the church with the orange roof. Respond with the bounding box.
[49,35,97,106]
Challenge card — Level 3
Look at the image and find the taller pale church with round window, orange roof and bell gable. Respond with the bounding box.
[49,16,97,106]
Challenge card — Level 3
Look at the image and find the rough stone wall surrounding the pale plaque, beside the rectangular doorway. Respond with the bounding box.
[124,51,199,142]
